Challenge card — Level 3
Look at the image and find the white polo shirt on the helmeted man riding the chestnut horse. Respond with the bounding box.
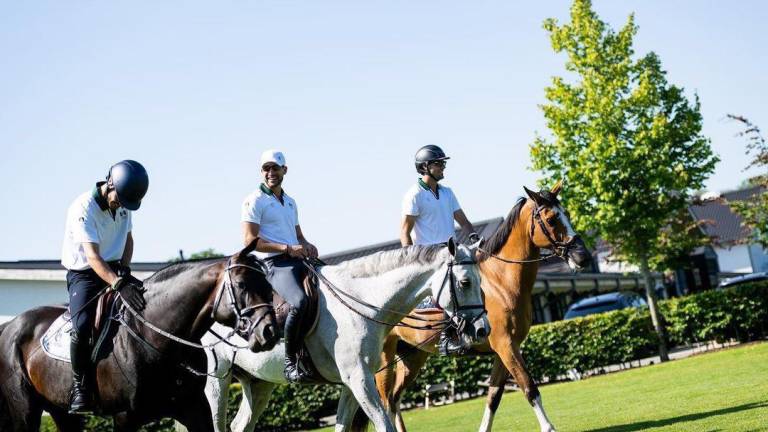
[403,179,461,245]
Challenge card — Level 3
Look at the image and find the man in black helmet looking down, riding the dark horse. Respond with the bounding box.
[61,160,149,414]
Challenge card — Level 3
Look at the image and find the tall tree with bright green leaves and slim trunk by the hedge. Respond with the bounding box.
[531,0,718,360]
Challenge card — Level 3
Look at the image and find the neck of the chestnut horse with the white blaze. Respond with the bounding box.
[480,201,541,304]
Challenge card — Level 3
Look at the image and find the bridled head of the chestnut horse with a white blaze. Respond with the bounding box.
[523,180,592,270]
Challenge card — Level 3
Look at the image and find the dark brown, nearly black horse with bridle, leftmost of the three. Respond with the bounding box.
[0,241,277,432]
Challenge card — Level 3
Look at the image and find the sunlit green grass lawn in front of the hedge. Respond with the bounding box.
[316,343,768,432]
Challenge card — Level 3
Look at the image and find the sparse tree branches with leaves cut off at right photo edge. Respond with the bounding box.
[727,114,768,248]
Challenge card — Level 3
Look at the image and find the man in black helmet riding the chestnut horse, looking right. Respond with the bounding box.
[400,145,480,354]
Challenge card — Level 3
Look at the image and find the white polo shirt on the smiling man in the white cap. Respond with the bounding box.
[240,184,299,258]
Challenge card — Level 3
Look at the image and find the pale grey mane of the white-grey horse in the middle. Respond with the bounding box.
[334,244,446,278]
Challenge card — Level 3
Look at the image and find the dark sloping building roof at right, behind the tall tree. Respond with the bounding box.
[689,186,764,245]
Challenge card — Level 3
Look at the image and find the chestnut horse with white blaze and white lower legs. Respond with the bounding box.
[364,182,592,432]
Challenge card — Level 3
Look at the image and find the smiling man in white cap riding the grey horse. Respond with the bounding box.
[241,150,317,382]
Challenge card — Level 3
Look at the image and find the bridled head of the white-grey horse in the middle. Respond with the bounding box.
[430,238,490,348]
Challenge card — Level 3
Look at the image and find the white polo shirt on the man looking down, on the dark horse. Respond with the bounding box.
[61,184,132,270]
